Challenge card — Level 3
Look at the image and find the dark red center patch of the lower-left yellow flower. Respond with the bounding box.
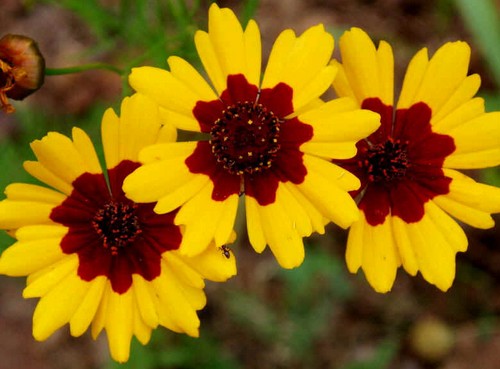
[50,161,182,293]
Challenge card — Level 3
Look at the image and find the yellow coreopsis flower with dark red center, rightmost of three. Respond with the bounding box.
[333,28,500,292]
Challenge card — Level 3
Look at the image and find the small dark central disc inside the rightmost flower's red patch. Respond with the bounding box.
[363,137,410,182]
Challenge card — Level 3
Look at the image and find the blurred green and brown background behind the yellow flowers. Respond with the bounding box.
[0,0,500,369]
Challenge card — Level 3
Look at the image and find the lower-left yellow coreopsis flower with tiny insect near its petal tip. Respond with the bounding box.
[0,95,236,362]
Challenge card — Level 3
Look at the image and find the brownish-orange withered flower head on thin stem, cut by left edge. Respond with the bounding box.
[0,34,45,113]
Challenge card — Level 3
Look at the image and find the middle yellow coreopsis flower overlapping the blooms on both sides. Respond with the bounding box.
[124,4,379,268]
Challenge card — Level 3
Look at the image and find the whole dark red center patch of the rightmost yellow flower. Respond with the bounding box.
[334,98,455,226]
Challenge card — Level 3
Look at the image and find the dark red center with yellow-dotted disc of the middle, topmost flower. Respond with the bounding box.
[186,74,313,205]
